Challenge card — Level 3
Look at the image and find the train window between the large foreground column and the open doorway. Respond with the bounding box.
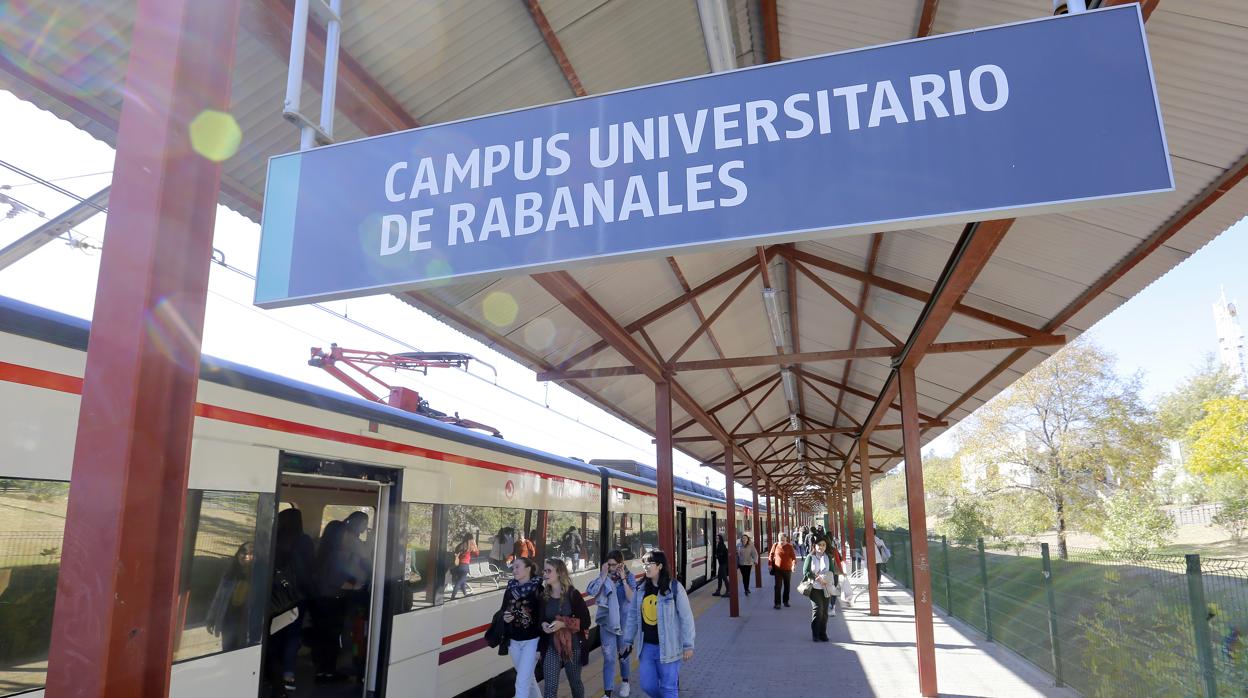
[173,489,273,662]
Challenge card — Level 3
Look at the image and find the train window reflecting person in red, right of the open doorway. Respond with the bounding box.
[443,504,526,599]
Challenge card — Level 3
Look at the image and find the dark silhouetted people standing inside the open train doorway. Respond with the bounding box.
[259,508,373,696]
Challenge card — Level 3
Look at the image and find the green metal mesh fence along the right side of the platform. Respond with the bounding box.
[880,531,1248,697]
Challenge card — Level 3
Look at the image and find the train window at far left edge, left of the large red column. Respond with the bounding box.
[0,479,70,696]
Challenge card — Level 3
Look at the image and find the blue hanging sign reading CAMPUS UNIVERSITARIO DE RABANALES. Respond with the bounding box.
[256,5,1174,307]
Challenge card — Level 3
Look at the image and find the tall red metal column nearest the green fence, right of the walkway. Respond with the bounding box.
[897,363,936,696]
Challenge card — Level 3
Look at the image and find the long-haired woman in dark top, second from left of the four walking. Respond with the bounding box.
[539,557,589,698]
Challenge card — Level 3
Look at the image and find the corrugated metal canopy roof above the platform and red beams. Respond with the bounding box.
[0,0,1248,496]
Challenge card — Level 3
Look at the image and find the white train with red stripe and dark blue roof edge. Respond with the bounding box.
[0,298,751,697]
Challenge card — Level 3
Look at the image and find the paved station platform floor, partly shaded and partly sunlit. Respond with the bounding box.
[559,574,1078,698]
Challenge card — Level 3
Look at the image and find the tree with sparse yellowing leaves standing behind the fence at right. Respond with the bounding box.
[961,340,1162,559]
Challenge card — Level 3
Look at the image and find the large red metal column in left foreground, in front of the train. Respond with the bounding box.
[46,0,240,698]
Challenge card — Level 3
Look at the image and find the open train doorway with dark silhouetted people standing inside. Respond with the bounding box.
[261,455,402,698]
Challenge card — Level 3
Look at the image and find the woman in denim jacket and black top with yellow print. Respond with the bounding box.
[622,549,696,698]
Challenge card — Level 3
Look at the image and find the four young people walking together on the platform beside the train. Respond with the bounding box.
[487,549,695,698]
